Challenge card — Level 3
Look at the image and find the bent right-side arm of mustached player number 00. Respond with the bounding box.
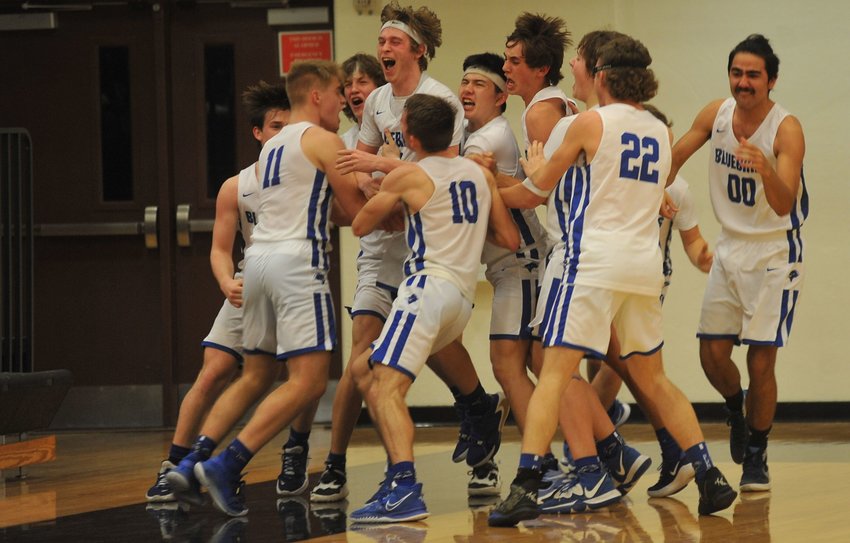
[735,116,806,216]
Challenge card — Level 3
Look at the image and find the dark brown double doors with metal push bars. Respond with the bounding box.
[0,2,338,426]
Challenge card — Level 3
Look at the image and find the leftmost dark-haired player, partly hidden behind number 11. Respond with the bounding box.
[145,81,290,502]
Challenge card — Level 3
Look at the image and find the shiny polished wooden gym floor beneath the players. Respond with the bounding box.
[0,423,850,543]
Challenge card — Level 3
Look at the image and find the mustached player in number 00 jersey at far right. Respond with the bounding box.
[670,34,809,491]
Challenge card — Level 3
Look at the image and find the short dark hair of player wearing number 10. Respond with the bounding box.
[404,94,457,153]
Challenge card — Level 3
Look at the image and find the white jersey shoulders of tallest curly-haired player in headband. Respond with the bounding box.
[360,72,463,162]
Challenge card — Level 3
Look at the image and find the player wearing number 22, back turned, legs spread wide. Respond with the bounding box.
[489,36,737,526]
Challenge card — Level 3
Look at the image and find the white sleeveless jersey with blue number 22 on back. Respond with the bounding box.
[564,103,671,296]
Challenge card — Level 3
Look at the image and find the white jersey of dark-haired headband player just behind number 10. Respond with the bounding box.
[461,115,546,269]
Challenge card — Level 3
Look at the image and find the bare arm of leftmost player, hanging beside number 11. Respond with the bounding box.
[210,176,242,307]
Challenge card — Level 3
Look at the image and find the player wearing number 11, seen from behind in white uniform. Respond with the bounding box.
[167,61,365,516]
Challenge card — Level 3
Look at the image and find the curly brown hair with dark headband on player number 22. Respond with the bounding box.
[598,36,658,103]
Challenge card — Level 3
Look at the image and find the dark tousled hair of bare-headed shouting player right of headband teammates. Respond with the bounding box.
[505,11,572,85]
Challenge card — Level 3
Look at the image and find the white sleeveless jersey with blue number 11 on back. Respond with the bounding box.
[254,122,332,270]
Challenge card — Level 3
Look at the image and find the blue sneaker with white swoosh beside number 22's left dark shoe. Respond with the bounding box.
[540,465,623,514]
